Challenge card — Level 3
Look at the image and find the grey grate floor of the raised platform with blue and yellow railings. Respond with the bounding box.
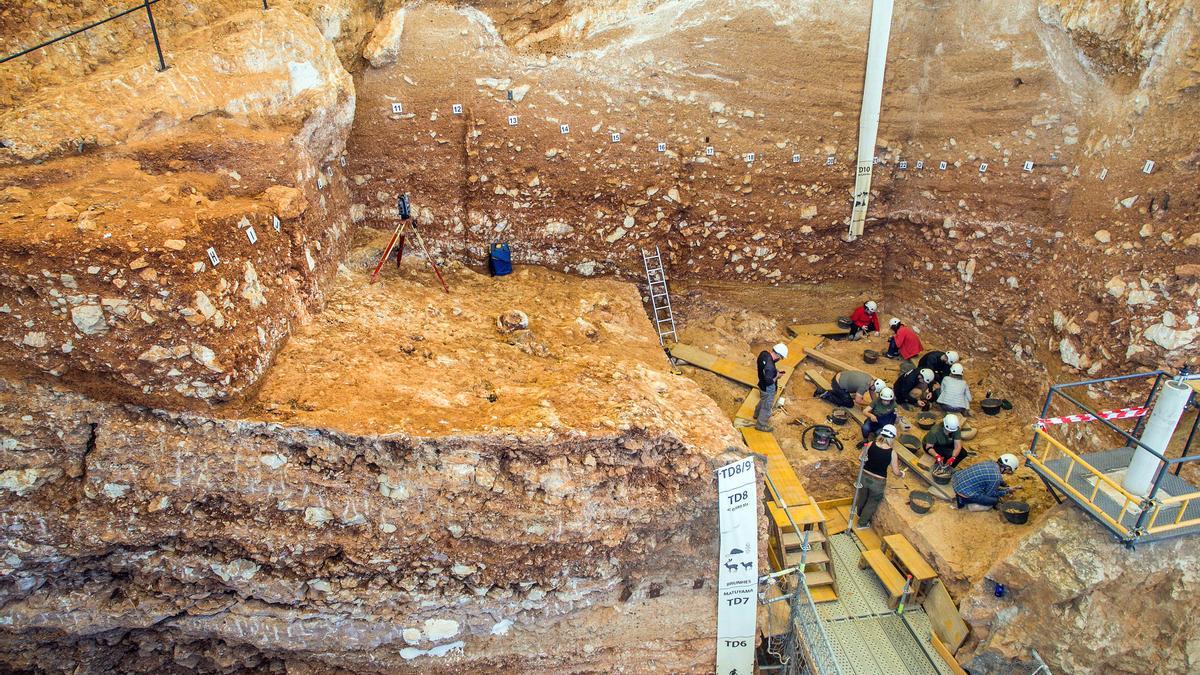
[1030,448,1200,543]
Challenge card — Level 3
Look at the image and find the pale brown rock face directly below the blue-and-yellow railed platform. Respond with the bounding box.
[960,504,1200,675]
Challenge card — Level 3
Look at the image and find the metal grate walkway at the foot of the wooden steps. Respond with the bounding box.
[817,533,952,675]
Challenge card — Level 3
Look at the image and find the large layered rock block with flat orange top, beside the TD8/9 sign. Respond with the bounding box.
[0,261,734,673]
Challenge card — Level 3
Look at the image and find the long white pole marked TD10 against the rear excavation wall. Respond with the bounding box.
[846,0,893,241]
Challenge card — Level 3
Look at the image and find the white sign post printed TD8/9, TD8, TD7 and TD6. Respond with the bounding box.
[716,458,758,675]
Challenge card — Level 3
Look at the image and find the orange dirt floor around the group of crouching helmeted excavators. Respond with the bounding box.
[672,276,1054,589]
